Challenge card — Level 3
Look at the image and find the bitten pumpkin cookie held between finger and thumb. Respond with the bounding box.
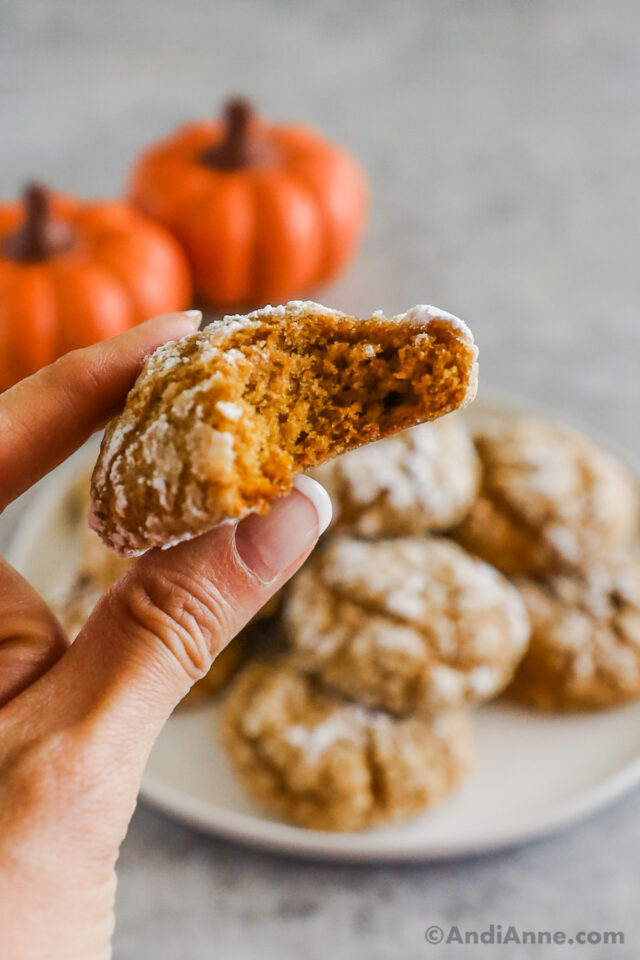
[91,301,477,556]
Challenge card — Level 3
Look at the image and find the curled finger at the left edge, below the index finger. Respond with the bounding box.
[0,559,68,706]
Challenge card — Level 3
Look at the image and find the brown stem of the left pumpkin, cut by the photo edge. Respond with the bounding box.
[3,183,73,263]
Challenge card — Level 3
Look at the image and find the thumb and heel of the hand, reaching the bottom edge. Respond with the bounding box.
[0,477,331,957]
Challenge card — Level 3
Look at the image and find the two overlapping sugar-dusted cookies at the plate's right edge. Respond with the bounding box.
[456,417,640,711]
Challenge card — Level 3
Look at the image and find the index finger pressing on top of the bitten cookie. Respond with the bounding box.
[0,310,201,510]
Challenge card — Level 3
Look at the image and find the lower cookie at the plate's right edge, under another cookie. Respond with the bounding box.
[509,558,640,710]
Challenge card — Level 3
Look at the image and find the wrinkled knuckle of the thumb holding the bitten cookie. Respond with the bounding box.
[112,567,233,680]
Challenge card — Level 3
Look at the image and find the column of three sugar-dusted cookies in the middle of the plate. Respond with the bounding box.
[222,417,529,830]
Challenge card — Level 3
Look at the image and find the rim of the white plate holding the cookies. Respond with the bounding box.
[4,390,640,864]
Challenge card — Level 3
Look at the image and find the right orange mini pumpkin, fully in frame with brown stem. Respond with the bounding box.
[130,99,368,305]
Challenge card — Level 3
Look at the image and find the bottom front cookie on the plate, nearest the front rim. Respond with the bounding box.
[221,657,471,830]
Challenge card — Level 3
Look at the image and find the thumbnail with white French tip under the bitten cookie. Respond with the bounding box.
[235,476,331,583]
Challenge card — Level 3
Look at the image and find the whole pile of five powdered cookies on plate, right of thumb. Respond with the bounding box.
[222,416,640,830]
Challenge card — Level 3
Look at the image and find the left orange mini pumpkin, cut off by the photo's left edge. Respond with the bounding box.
[0,184,191,390]
